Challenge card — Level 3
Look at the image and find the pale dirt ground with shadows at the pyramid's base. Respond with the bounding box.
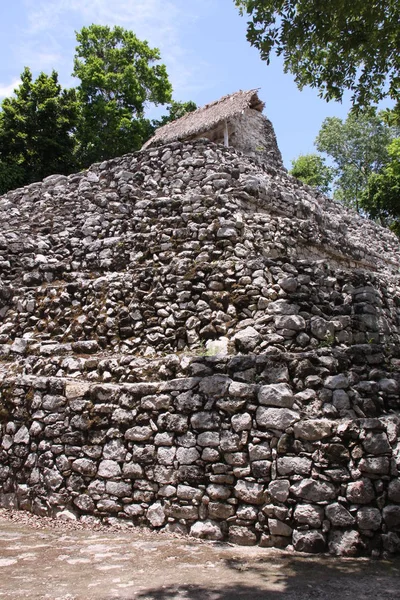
[0,511,400,600]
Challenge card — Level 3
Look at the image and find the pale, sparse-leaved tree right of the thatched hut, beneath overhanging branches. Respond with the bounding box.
[315,111,396,211]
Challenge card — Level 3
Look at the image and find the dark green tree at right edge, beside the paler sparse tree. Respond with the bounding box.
[361,138,400,235]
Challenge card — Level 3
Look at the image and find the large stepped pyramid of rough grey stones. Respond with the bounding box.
[0,92,400,556]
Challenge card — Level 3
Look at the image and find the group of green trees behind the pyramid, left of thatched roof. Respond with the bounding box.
[0,25,197,194]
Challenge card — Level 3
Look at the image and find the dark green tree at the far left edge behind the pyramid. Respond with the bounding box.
[0,68,78,191]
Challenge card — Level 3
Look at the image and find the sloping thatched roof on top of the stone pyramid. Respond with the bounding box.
[143,90,264,149]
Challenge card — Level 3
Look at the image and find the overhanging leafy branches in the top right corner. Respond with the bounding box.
[235,0,400,106]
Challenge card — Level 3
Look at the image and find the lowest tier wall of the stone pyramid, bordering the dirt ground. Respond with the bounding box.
[0,351,400,556]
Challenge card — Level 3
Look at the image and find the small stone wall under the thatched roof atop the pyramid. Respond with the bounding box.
[229,108,283,169]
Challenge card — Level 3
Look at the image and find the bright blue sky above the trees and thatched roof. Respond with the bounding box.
[0,0,366,167]
